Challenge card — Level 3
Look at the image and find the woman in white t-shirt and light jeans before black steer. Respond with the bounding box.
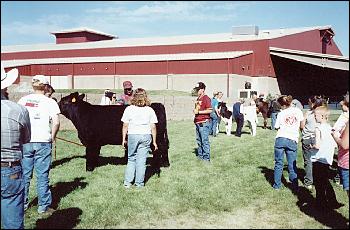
[121,88,158,188]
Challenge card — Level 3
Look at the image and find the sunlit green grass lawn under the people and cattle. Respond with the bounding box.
[25,113,349,229]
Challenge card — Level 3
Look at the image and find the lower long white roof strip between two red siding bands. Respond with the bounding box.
[2,51,253,68]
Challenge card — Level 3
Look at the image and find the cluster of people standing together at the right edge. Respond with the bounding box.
[273,94,349,209]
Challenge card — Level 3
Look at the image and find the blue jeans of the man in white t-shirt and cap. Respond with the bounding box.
[22,142,52,212]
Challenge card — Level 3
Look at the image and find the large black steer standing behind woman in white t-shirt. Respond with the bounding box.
[58,92,170,173]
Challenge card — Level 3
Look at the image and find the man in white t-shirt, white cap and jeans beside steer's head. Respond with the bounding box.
[18,75,61,214]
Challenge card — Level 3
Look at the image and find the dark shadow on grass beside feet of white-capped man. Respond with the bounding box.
[29,177,87,209]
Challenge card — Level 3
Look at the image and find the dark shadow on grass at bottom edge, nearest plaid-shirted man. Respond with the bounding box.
[36,208,83,229]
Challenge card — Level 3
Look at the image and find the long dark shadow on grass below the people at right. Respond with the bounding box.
[258,166,348,229]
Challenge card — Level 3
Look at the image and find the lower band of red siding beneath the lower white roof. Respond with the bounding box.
[20,54,258,76]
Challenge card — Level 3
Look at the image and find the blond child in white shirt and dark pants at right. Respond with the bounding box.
[311,106,342,209]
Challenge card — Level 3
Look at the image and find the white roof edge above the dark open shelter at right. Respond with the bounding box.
[270,47,349,71]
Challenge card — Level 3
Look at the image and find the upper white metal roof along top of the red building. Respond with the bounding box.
[1,26,331,53]
